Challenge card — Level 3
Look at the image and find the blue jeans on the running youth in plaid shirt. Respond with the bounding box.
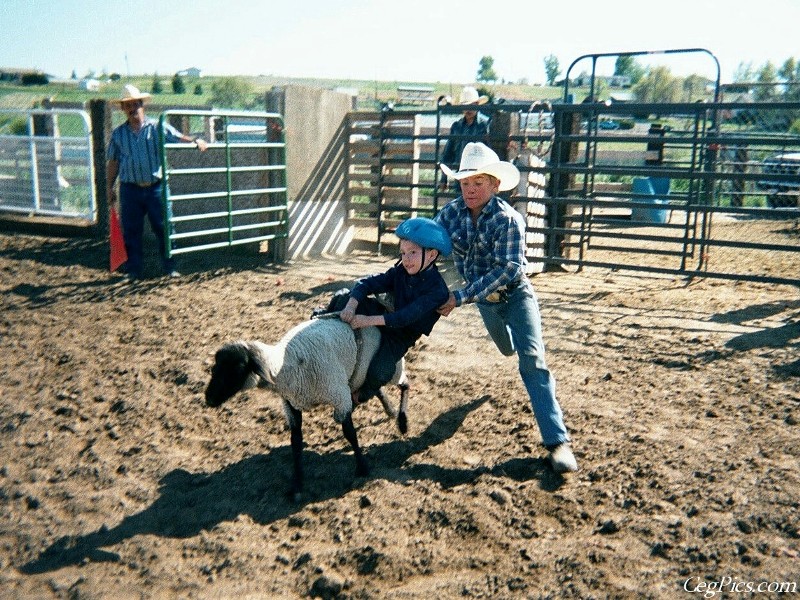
[478,279,569,446]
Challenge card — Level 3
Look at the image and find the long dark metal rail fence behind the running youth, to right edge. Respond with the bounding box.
[347,102,800,284]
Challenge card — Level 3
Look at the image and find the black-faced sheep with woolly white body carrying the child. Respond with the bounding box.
[205,318,409,500]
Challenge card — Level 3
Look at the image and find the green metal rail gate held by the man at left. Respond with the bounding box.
[159,110,289,256]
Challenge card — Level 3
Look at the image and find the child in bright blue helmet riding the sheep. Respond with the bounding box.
[339,217,451,405]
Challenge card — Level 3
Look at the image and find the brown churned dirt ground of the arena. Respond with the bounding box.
[0,232,800,599]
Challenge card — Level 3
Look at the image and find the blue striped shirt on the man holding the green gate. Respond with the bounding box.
[106,119,181,183]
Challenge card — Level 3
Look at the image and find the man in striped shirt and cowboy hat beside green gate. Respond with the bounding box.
[106,85,208,281]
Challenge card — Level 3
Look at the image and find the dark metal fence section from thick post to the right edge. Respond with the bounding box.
[542,103,800,283]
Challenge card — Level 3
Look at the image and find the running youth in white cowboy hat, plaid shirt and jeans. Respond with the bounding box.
[436,142,578,473]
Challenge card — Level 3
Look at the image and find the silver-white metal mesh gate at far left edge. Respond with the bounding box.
[0,109,97,224]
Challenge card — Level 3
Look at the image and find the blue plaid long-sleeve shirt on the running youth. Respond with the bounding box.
[436,196,527,306]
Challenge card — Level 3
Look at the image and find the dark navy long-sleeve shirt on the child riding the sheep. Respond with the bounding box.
[350,264,450,340]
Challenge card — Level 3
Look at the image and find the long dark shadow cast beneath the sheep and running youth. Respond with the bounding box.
[19,396,563,574]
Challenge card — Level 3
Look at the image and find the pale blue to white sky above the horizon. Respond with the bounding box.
[0,0,800,83]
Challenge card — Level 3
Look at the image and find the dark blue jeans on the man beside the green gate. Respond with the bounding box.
[119,183,175,278]
